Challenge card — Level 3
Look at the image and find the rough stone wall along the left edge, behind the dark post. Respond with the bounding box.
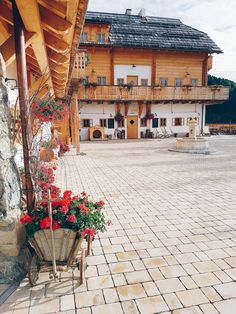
[0,55,23,282]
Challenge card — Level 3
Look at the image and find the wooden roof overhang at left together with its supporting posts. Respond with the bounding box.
[0,0,88,210]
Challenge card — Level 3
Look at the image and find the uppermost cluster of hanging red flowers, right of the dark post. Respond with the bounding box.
[31,99,68,122]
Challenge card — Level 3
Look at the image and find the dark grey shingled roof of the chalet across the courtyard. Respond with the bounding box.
[80,12,222,53]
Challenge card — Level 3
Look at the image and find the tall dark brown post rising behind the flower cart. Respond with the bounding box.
[12,0,34,211]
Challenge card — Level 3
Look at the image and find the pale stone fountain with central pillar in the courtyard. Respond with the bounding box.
[170,117,213,154]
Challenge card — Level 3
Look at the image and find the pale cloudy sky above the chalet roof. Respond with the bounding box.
[89,0,236,82]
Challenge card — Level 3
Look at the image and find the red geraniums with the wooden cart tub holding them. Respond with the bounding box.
[20,191,111,261]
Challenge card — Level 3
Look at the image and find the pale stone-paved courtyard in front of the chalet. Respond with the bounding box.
[0,136,236,314]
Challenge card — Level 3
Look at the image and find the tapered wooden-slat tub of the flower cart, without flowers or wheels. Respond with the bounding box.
[29,228,84,262]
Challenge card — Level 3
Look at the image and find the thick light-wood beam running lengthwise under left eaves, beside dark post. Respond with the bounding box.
[16,0,54,95]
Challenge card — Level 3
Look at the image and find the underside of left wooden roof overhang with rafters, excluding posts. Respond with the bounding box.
[0,0,88,98]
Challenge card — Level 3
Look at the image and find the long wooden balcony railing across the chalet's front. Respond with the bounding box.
[78,86,229,103]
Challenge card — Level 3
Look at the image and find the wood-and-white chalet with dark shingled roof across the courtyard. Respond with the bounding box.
[75,10,229,140]
